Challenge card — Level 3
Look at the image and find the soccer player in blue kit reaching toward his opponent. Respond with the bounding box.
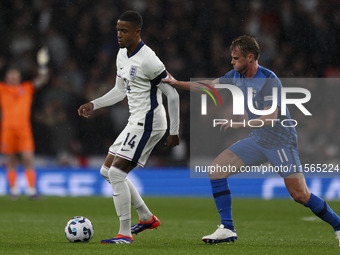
[163,35,340,246]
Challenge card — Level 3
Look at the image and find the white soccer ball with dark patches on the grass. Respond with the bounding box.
[65,216,94,243]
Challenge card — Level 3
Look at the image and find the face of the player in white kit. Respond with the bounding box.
[116,20,141,51]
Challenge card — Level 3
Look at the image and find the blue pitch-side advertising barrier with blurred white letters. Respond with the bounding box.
[0,167,340,200]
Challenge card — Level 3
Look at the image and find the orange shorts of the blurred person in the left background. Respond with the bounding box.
[0,129,34,154]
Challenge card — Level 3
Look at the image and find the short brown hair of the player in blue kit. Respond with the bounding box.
[230,35,260,60]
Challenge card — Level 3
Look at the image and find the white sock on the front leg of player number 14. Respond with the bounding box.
[109,166,132,236]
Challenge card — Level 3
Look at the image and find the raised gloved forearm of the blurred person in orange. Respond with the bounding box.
[33,47,50,88]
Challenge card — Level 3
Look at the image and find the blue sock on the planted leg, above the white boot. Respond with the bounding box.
[210,179,234,230]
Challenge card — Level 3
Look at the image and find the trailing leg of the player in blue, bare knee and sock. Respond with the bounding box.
[284,173,340,241]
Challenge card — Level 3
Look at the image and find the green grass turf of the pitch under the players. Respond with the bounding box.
[0,197,340,255]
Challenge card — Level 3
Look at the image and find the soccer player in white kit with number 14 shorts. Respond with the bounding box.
[78,11,179,244]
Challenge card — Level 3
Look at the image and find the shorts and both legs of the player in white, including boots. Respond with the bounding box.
[101,124,165,243]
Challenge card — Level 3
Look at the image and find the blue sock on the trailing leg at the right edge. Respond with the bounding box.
[306,193,340,231]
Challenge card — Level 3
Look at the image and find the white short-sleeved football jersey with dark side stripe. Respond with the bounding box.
[116,41,167,130]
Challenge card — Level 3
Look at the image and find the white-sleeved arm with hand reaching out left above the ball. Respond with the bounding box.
[78,75,126,118]
